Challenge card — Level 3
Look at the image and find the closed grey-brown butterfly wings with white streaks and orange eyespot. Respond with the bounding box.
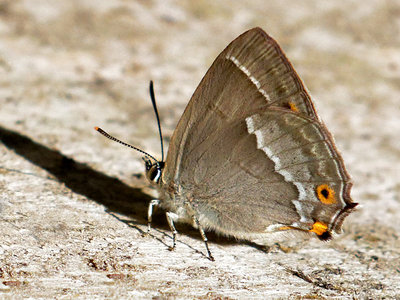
[162,28,351,237]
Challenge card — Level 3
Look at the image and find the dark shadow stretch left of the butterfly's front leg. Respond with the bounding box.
[0,127,151,224]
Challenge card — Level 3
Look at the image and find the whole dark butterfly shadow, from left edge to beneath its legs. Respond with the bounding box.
[0,126,236,252]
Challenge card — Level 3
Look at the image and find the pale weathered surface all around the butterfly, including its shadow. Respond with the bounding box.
[0,0,400,298]
